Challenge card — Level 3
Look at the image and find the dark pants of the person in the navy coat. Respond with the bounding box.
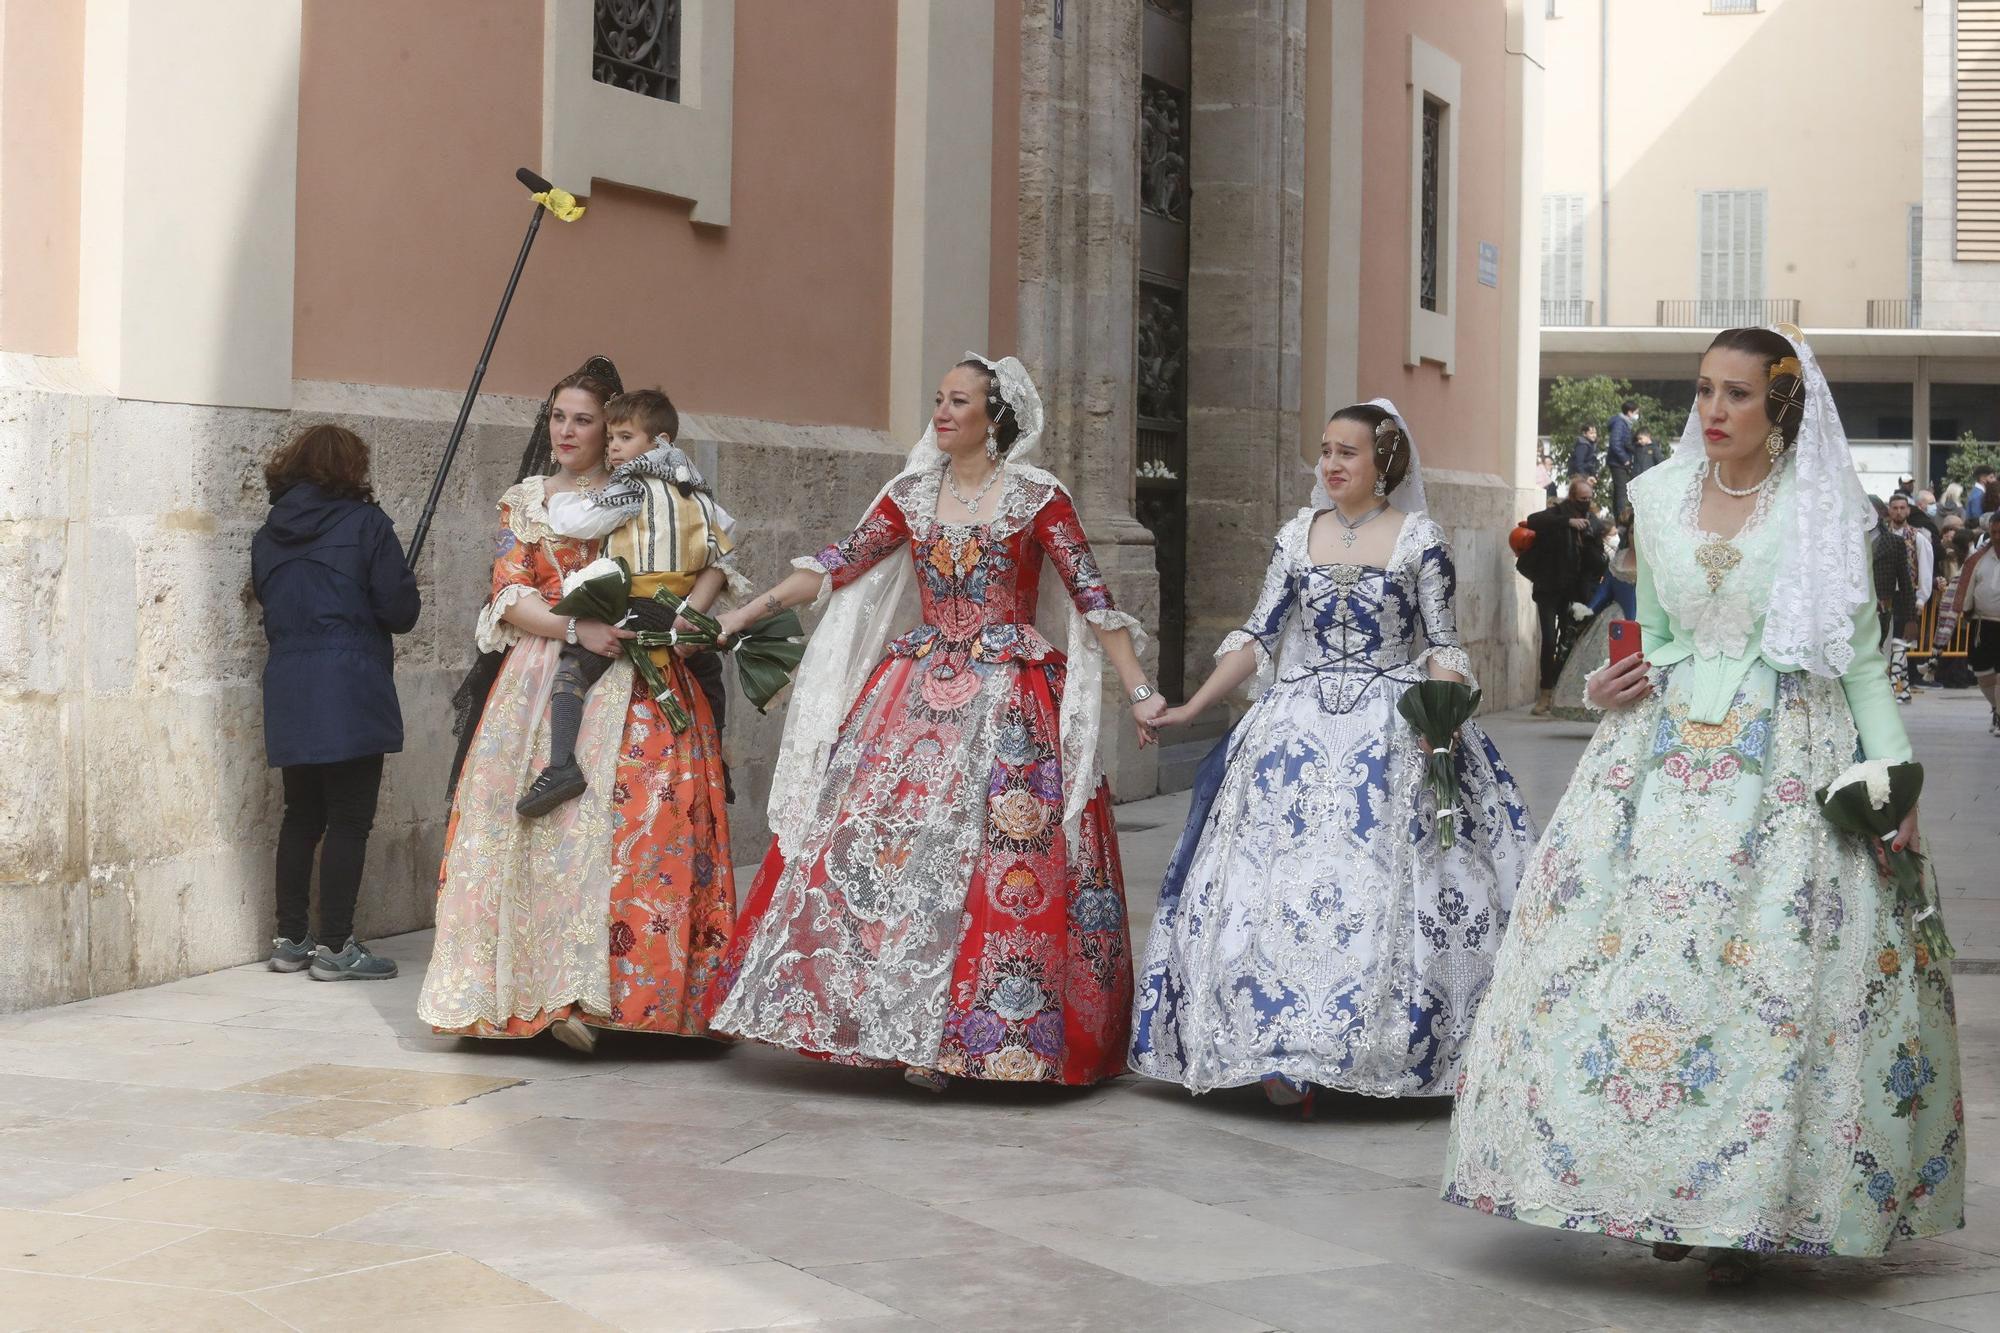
[278,755,382,949]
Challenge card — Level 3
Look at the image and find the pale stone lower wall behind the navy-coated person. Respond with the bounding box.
[0,356,902,1011]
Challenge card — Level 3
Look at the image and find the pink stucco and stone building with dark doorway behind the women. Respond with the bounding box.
[0,0,1542,1009]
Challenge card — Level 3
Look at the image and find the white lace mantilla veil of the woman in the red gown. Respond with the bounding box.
[768,352,1144,859]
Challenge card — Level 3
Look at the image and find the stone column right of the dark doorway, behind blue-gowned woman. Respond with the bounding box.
[1188,0,1310,679]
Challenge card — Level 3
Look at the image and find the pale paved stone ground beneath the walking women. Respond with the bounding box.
[0,695,2000,1333]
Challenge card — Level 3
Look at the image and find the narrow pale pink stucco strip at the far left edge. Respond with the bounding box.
[0,0,84,356]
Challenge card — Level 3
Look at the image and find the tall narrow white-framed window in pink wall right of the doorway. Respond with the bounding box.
[1404,36,1460,374]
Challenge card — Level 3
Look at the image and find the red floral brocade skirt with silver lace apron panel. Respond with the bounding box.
[710,654,1132,1083]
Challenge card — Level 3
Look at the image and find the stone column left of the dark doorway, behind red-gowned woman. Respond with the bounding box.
[1020,0,1160,799]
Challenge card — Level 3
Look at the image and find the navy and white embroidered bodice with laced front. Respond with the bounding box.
[1216,508,1472,713]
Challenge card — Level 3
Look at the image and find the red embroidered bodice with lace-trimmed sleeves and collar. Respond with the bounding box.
[794,468,1124,662]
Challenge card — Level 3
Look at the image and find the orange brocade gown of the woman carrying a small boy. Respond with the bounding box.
[418,478,734,1037]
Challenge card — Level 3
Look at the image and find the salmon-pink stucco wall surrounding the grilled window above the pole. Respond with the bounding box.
[294,0,896,426]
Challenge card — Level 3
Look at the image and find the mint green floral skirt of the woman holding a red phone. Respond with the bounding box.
[1444,662,1966,1255]
